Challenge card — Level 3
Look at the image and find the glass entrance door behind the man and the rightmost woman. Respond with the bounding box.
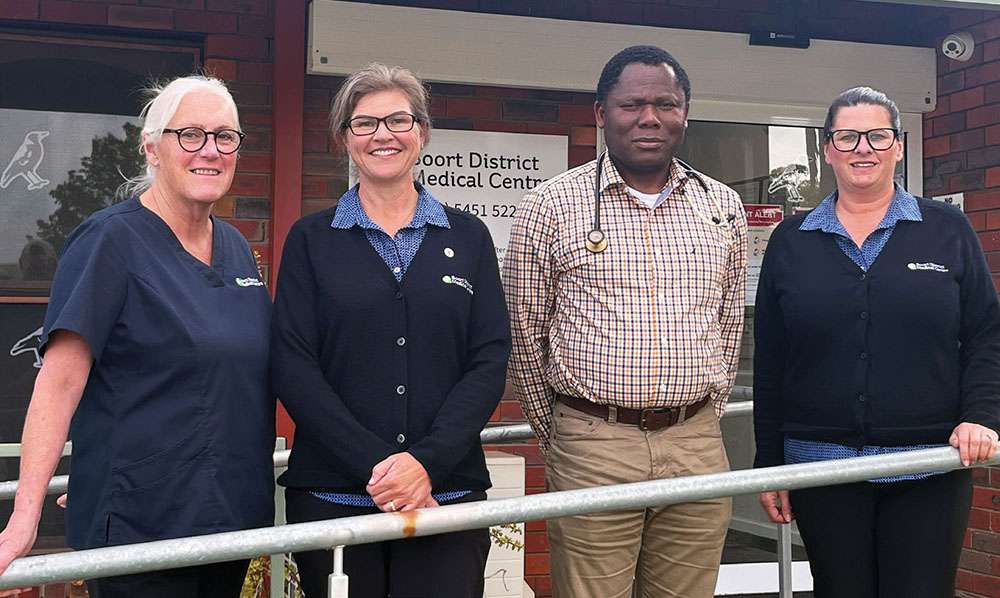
[678,119,907,591]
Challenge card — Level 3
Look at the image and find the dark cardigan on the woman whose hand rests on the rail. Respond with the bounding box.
[754,199,1000,467]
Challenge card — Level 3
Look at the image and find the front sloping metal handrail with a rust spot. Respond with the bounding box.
[0,447,984,589]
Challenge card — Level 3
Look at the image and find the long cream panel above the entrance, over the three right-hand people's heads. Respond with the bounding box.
[307,0,937,112]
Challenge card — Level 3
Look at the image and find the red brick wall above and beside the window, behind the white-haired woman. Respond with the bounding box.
[0,0,274,277]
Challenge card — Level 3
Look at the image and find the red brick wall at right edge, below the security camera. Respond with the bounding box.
[924,11,1000,598]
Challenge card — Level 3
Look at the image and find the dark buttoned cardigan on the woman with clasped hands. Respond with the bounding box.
[271,208,510,494]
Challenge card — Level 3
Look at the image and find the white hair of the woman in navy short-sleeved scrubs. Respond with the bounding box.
[118,75,240,197]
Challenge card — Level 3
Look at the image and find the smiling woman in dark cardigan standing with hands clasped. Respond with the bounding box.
[271,64,510,598]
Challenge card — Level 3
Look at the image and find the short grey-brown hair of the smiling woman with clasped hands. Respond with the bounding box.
[330,62,431,149]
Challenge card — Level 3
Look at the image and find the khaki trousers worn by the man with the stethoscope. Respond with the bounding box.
[545,402,732,598]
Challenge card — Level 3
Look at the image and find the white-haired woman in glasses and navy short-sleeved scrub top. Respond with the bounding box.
[0,76,275,598]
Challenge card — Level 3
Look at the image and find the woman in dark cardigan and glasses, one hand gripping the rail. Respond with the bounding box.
[754,87,1000,598]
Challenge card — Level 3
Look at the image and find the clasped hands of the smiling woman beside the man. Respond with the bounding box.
[365,453,438,513]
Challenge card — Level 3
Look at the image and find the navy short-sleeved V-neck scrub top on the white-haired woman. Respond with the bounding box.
[42,198,275,549]
